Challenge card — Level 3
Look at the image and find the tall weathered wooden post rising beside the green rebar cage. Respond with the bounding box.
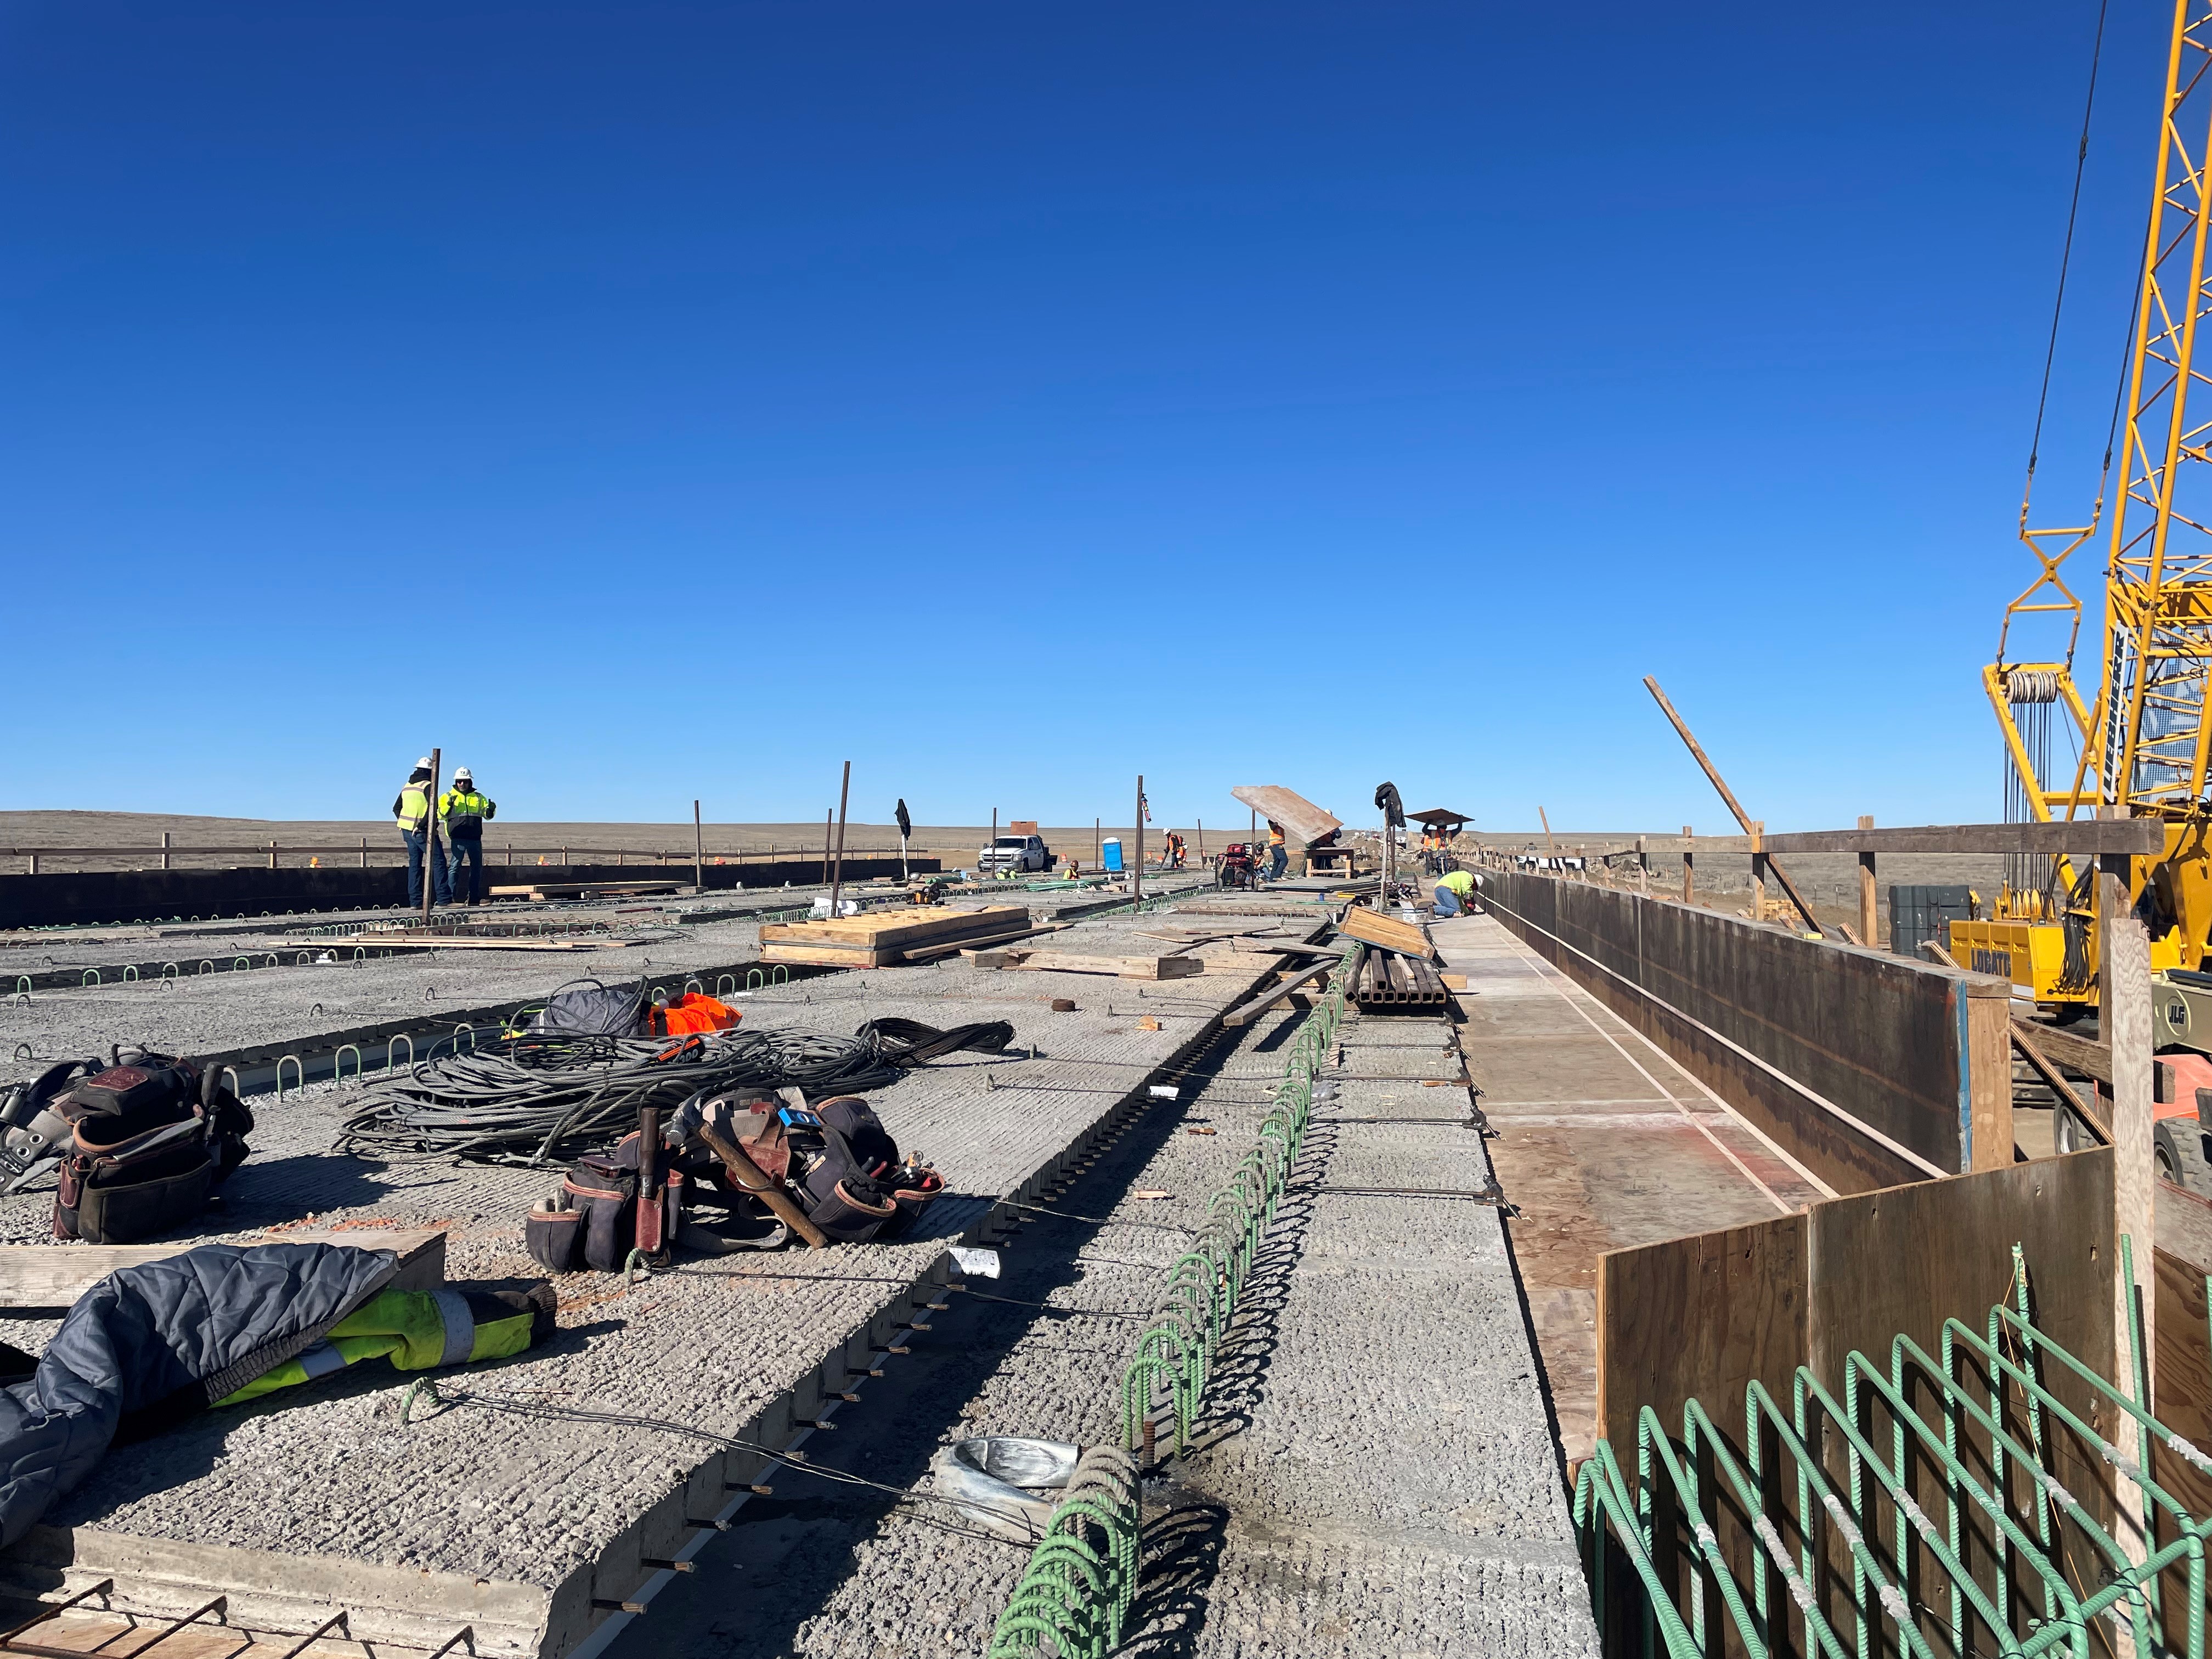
[2097,845,2159,1562]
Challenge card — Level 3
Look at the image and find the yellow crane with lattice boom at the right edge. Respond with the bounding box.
[1951,0,2212,1020]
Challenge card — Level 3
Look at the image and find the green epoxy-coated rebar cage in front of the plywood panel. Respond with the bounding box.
[1573,1239,2212,1659]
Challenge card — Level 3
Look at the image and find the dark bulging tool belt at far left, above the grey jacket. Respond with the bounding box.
[49,1051,255,1243]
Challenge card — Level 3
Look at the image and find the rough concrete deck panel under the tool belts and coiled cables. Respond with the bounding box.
[0,889,1256,1652]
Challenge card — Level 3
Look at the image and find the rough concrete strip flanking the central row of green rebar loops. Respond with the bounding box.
[606,929,1597,1659]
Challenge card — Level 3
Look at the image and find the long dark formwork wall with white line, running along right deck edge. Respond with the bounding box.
[1482,870,2013,1192]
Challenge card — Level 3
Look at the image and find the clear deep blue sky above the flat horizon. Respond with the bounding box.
[0,0,2165,830]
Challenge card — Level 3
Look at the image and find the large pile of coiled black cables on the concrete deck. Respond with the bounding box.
[334,1020,1013,1164]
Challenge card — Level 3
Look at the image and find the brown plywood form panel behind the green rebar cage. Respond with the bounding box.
[1597,1148,2114,1655]
